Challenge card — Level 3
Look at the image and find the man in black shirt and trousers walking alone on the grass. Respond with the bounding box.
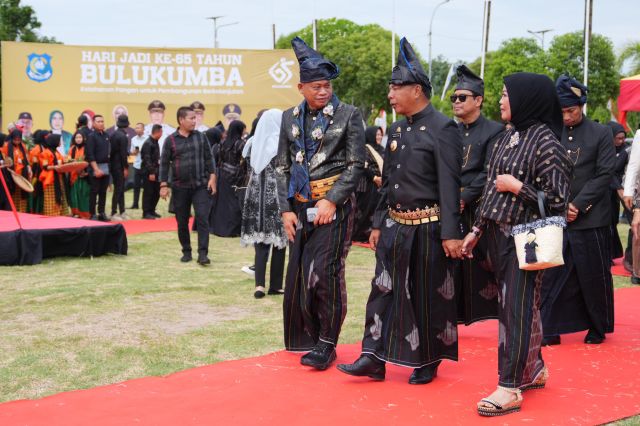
[160,107,216,265]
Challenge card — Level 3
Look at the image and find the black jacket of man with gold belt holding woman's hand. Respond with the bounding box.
[373,104,462,240]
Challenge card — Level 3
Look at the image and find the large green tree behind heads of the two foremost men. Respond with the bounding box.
[276,18,449,121]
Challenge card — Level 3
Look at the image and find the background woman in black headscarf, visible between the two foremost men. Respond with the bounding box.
[353,126,384,242]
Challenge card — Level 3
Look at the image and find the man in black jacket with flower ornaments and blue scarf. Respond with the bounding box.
[274,37,365,370]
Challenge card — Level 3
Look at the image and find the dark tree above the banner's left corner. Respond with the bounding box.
[0,0,59,118]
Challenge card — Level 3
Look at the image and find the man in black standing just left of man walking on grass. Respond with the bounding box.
[140,124,162,219]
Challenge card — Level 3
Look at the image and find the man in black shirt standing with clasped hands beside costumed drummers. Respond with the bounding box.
[85,114,111,221]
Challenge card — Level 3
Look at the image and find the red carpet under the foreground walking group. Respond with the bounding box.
[0,289,640,426]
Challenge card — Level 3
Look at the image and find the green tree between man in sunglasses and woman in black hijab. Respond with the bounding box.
[469,38,545,120]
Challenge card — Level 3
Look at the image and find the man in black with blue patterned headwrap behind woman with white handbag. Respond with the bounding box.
[541,76,615,344]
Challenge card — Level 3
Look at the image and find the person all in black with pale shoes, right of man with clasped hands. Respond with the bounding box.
[110,115,129,221]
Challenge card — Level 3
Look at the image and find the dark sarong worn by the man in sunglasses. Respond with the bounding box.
[456,206,498,325]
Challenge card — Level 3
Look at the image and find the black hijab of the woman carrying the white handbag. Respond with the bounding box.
[504,72,563,139]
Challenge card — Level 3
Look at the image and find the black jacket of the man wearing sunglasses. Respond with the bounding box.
[458,114,504,205]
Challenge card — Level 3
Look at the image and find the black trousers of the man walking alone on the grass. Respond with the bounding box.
[173,186,211,256]
